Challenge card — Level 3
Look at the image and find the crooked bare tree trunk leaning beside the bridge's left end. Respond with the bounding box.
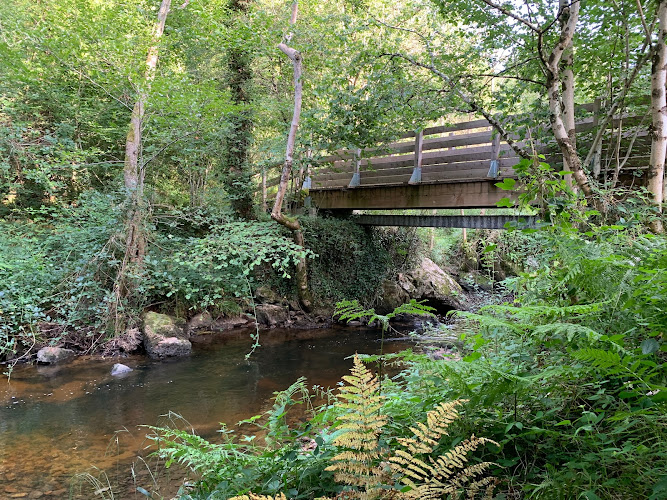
[271,0,313,312]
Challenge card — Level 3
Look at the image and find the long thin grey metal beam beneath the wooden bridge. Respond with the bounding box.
[351,215,537,229]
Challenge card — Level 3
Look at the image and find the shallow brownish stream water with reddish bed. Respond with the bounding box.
[0,329,409,499]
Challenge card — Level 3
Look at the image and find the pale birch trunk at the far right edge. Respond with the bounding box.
[648,0,667,233]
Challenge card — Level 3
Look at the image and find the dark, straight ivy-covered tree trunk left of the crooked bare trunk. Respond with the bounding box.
[223,0,255,219]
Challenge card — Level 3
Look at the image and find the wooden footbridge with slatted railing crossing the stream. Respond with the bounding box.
[269,101,650,227]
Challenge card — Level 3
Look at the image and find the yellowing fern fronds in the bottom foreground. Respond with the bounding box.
[326,356,496,500]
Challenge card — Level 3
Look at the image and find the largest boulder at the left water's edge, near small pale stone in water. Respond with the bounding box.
[144,311,192,359]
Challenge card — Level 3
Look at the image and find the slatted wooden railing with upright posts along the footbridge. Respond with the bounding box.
[267,97,650,190]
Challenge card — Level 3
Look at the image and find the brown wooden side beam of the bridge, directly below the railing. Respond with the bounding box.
[310,179,516,210]
